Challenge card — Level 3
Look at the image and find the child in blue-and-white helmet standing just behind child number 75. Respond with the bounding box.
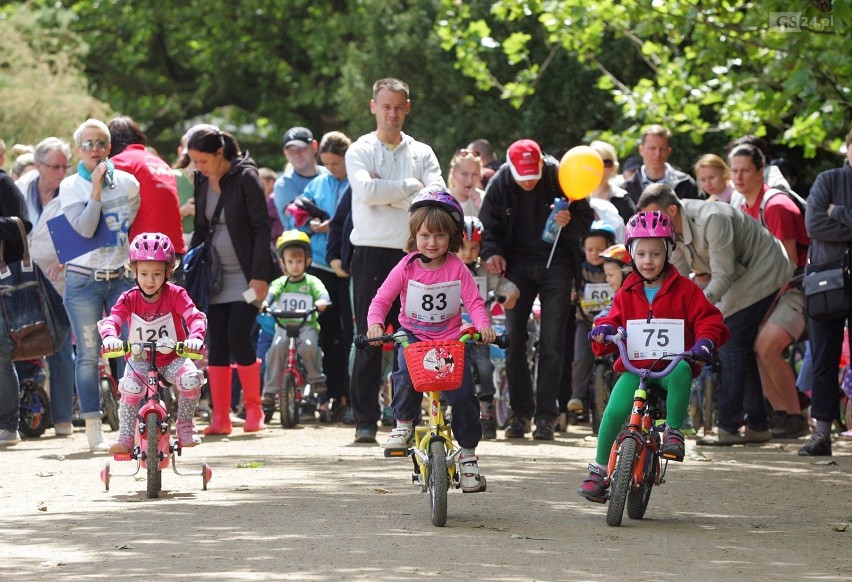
[568,220,615,414]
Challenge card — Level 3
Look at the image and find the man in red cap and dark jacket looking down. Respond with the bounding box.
[479,139,594,440]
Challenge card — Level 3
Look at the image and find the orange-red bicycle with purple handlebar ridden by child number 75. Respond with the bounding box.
[606,328,689,526]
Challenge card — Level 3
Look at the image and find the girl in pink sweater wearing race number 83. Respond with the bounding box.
[367,189,497,493]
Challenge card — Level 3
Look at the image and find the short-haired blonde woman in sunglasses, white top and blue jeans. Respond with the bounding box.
[56,119,139,451]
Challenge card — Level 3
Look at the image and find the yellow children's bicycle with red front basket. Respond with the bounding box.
[355,330,509,527]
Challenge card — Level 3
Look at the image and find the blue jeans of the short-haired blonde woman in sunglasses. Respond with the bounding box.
[65,271,134,418]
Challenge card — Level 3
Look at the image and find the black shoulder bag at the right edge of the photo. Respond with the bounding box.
[802,250,852,321]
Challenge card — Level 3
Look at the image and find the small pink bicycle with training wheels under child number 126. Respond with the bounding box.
[101,341,213,499]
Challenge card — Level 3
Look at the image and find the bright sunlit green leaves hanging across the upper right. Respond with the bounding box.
[438,0,852,157]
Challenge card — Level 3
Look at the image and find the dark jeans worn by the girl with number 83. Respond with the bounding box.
[393,334,482,449]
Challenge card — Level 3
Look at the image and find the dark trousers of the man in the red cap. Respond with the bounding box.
[506,261,574,420]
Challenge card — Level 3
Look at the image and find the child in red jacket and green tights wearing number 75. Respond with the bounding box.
[578,211,730,503]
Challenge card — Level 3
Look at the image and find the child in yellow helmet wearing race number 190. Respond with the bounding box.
[263,230,331,422]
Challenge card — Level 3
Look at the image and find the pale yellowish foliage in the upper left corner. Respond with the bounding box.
[0,7,109,162]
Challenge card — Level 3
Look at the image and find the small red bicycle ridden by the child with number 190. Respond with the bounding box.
[266,306,318,428]
